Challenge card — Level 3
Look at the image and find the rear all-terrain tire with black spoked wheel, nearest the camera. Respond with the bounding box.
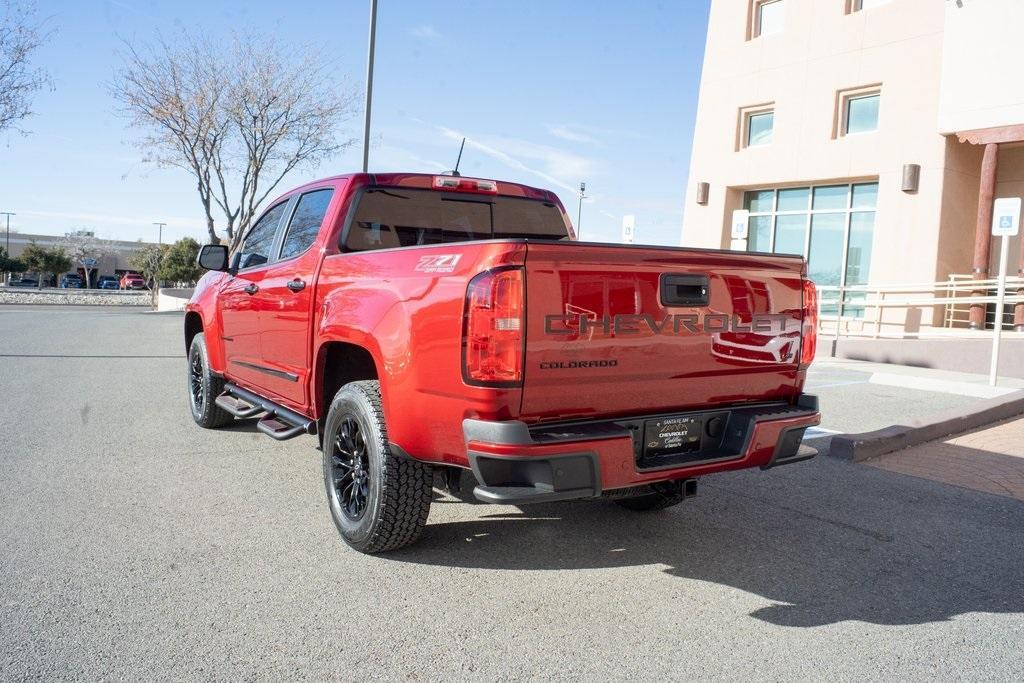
[324,380,433,553]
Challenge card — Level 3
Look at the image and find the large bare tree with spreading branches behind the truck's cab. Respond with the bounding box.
[112,32,358,248]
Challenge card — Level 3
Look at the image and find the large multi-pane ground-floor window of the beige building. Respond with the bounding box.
[743,182,879,317]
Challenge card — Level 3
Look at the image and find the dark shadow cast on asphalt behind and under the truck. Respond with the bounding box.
[387,458,1024,627]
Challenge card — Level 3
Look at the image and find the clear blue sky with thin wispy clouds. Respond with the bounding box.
[0,0,709,244]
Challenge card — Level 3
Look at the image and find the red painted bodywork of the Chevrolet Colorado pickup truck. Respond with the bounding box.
[186,174,816,488]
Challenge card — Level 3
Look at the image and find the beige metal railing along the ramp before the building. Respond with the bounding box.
[818,274,1024,339]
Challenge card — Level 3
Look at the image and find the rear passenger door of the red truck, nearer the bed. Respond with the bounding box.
[257,187,335,410]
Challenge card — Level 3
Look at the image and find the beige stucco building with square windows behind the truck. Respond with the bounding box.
[682,0,1024,325]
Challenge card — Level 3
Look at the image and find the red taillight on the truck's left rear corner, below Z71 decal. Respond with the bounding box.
[462,267,526,386]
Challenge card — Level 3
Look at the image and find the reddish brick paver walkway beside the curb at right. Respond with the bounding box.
[865,418,1024,501]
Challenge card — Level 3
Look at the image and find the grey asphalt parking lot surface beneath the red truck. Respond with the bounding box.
[0,306,1024,680]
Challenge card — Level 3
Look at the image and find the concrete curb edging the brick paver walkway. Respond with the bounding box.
[824,391,1024,462]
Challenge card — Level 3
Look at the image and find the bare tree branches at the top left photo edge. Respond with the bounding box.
[0,0,49,131]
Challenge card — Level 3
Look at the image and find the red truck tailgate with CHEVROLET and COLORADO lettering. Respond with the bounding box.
[520,243,804,420]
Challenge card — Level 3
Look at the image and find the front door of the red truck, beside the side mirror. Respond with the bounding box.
[217,201,288,388]
